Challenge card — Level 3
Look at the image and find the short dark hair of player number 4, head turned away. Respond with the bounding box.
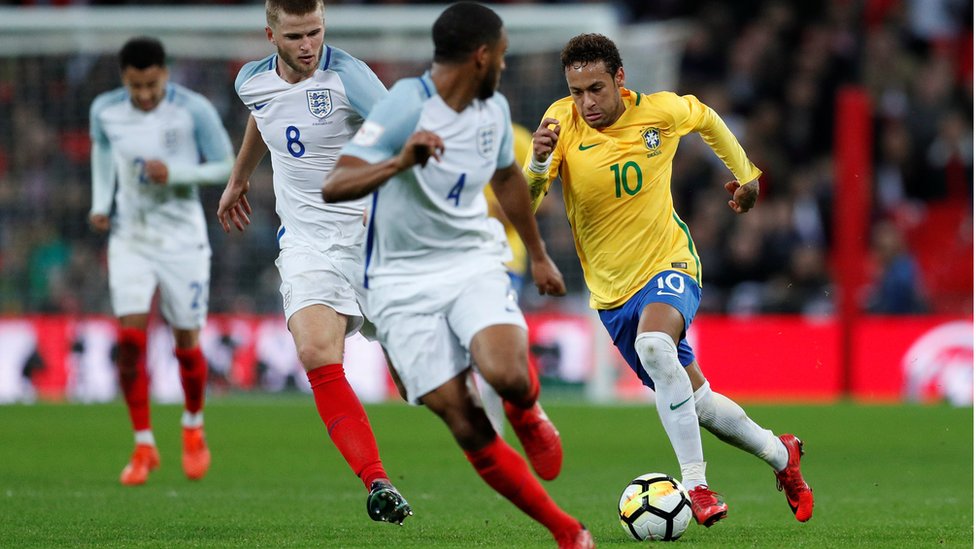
[431,2,502,63]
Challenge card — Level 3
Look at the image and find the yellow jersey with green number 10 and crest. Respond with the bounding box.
[524,88,762,309]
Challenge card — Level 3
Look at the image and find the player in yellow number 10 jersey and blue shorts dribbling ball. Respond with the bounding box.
[524,34,813,526]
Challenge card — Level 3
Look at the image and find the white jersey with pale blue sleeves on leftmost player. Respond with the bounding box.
[90,83,234,251]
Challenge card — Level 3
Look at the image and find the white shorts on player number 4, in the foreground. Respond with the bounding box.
[368,264,527,404]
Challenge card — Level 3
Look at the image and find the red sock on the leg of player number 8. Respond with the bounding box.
[308,364,388,489]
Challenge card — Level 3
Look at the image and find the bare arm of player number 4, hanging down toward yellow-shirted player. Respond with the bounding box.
[491,163,566,295]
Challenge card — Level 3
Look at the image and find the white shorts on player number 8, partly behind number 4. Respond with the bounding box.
[275,246,366,336]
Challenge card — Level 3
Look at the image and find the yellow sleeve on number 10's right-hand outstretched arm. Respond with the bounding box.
[670,95,762,185]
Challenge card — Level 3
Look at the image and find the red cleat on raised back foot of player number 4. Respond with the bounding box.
[505,402,563,480]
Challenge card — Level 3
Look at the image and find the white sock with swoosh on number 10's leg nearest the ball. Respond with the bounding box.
[634,332,706,490]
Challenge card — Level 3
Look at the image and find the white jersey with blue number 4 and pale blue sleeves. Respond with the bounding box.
[343,74,515,287]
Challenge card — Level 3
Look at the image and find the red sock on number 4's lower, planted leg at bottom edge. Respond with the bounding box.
[464,437,580,536]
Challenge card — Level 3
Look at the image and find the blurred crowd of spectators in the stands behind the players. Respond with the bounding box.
[0,0,973,314]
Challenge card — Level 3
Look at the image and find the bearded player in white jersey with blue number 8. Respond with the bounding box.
[217,0,413,524]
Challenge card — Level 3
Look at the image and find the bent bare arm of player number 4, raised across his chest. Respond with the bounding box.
[322,130,444,203]
